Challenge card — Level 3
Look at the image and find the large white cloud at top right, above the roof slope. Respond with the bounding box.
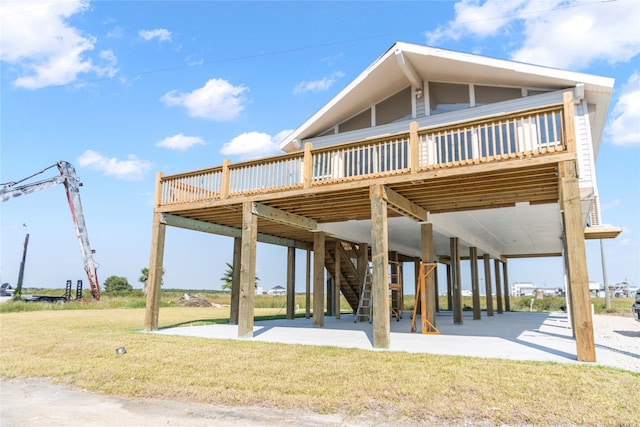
[425,0,640,69]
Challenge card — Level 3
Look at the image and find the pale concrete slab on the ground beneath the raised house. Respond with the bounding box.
[154,312,632,367]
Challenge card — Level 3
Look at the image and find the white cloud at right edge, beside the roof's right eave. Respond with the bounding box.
[606,71,640,145]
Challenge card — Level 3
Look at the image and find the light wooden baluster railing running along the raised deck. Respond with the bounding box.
[160,105,566,205]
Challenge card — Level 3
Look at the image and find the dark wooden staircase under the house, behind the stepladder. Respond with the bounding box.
[325,242,364,313]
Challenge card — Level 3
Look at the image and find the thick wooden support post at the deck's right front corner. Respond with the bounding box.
[558,161,596,362]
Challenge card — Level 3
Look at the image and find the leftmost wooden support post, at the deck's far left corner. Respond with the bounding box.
[144,172,167,331]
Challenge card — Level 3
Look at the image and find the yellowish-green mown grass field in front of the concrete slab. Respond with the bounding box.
[0,292,640,426]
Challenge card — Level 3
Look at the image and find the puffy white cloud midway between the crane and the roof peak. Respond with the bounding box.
[160,79,249,121]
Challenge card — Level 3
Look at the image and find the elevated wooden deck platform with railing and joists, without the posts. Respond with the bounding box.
[156,105,575,247]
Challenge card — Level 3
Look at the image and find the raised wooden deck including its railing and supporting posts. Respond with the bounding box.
[145,91,595,361]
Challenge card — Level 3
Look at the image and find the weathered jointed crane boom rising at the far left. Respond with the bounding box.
[0,161,100,300]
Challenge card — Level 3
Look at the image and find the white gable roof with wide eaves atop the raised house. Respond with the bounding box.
[280,42,614,152]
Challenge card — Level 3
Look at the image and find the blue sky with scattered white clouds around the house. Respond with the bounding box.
[0,0,640,290]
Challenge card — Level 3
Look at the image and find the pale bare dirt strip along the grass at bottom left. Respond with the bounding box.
[0,378,380,427]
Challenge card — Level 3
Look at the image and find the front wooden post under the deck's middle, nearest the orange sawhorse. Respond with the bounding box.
[370,185,391,348]
